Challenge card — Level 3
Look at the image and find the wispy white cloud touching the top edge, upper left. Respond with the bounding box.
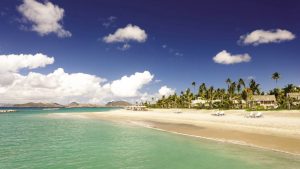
[17,0,72,37]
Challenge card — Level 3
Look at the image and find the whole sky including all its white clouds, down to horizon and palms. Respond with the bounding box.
[0,0,300,104]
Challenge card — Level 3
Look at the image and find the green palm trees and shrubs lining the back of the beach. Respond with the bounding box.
[143,72,300,109]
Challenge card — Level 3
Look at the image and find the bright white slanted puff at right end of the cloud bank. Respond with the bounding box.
[110,71,154,97]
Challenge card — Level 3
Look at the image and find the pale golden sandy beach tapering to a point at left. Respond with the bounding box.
[49,109,300,155]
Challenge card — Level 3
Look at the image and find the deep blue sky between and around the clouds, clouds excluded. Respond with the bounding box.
[0,0,300,103]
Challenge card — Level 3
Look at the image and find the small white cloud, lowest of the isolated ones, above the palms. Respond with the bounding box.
[213,50,251,65]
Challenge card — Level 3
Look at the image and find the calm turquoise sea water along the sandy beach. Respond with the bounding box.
[0,108,300,169]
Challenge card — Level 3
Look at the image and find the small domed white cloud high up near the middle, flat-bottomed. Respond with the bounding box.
[103,24,147,43]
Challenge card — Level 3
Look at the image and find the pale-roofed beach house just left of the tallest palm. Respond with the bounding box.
[248,95,278,109]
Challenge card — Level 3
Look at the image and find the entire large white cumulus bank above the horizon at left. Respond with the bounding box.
[0,54,154,103]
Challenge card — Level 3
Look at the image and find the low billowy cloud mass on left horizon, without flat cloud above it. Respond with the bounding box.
[0,68,105,102]
